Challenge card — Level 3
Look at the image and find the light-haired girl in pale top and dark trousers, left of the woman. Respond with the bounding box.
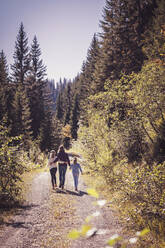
[48,150,57,189]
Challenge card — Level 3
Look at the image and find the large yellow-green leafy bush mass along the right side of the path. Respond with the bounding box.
[77,61,165,246]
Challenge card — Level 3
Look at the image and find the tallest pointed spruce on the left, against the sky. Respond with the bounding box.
[11,23,32,146]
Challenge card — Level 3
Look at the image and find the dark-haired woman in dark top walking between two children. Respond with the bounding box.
[54,146,70,189]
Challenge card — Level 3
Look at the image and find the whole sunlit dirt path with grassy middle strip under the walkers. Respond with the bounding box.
[0,170,120,248]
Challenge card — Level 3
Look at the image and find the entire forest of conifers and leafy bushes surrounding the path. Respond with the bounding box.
[0,0,165,248]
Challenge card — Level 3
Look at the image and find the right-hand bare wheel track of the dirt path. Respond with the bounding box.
[68,170,121,248]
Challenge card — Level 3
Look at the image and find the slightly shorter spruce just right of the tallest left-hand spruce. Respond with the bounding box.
[25,36,46,139]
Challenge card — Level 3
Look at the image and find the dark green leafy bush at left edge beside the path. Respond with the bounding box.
[0,125,25,203]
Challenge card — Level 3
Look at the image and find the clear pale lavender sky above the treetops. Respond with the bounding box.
[0,0,105,82]
